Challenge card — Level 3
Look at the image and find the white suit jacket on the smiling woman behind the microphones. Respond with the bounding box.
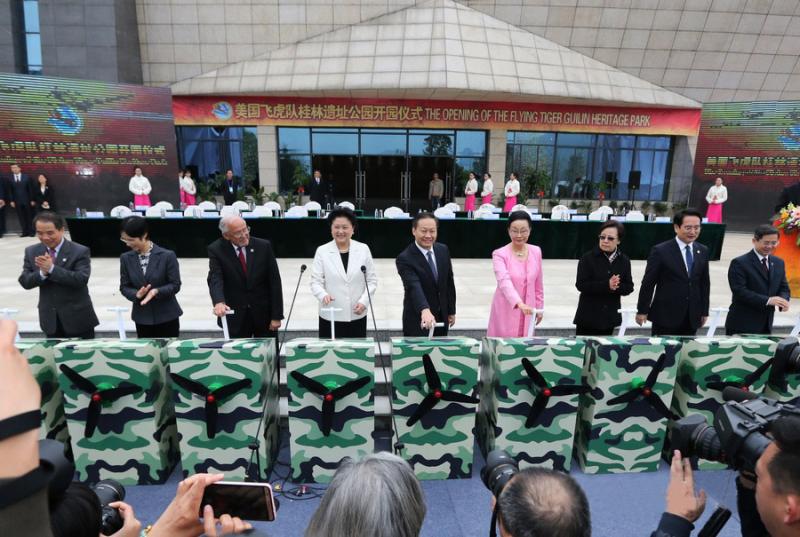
[311,239,378,322]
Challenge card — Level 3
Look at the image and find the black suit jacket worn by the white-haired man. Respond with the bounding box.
[208,237,283,334]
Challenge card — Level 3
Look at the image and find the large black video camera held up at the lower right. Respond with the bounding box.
[672,388,800,472]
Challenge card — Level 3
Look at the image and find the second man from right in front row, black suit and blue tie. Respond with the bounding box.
[636,209,711,336]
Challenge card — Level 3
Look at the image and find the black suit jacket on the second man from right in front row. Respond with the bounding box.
[636,239,711,329]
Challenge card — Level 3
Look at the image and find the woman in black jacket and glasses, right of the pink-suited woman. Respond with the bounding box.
[572,220,633,336]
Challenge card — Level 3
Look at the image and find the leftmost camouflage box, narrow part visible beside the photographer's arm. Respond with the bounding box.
[16,339,69,449]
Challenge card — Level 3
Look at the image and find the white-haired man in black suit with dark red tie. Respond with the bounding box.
[208,216,283,338]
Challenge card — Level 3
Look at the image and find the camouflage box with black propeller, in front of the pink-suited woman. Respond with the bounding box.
[477,338,585,471]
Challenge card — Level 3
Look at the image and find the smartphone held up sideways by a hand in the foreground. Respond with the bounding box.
[200,481,277,522]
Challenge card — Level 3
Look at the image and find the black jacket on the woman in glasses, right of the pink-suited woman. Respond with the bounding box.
[572,247,633,330]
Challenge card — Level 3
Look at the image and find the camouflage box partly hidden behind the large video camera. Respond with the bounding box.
[664,336,777,470]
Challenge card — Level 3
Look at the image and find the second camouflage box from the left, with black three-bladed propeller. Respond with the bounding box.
[55,339,178,485]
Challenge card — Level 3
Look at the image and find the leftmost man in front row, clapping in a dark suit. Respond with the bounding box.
[19,211,99,339]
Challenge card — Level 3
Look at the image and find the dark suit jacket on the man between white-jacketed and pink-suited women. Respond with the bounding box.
[395,242,456,336]
